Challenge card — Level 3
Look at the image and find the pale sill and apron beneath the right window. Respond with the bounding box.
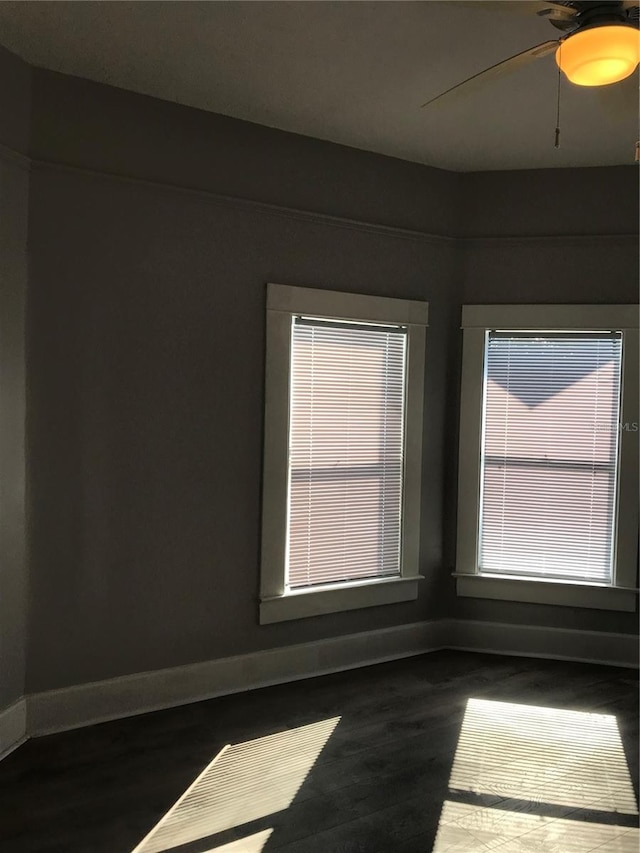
[453,572,638,612]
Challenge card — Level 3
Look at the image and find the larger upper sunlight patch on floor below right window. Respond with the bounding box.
[449,699,638,815]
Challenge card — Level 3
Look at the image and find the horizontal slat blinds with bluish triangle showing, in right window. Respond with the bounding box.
[479,332,622,583]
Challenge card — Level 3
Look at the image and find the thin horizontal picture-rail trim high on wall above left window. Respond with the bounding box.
[26,159,456,245]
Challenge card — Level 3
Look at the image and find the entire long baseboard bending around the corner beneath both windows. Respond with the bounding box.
[27,619,638,737]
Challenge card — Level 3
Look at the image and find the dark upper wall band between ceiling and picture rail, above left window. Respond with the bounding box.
[31,69,462,234]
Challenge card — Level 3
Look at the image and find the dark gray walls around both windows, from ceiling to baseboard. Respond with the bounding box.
[8,65,637,691]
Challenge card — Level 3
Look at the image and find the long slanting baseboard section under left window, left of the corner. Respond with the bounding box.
[27,620,446,736]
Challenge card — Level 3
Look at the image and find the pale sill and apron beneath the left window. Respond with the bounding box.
[260,575,422,625]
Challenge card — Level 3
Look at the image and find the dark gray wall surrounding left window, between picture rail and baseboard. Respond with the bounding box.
[29,161,451,690]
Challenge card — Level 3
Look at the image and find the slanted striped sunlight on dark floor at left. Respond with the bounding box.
[133,717,340,853]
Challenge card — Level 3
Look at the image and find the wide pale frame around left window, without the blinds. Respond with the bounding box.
[260,284,428,624]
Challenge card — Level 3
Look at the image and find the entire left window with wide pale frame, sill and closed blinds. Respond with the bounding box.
[260,284,427,623]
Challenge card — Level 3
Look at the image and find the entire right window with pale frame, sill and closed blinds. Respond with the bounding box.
[455,306,638,610]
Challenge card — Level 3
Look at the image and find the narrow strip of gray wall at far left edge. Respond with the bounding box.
[0,48,30,711]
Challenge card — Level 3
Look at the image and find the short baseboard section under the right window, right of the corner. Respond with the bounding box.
[447,619,639,668]
